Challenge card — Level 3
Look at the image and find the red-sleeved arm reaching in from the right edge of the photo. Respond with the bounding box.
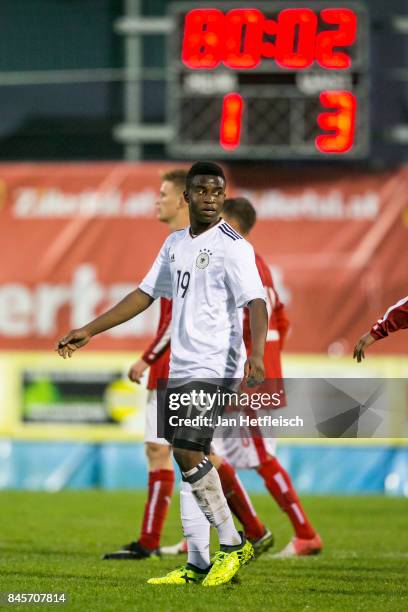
[353,295,408,363]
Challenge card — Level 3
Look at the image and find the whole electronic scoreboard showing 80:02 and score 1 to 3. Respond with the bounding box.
[168,0,370,160]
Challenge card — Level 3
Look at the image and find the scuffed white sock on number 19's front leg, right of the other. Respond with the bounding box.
[184,467,242,546]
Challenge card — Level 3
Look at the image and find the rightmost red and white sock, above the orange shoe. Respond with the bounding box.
[258,457,316,540]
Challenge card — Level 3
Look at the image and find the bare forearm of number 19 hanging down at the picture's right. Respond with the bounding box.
[244,298,268,384]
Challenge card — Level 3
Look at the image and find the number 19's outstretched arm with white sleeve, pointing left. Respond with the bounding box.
[56,238,171,359]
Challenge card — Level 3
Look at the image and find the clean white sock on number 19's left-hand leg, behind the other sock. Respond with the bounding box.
[180,481,210,569]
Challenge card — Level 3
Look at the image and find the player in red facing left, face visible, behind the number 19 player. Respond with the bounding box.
[104,169,273,560]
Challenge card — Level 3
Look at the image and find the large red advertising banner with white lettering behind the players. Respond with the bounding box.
[0,163,408,354]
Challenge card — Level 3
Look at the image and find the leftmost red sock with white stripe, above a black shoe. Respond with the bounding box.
[138,470,174,550]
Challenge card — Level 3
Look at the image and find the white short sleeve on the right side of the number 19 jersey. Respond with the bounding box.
[225,239,266,308]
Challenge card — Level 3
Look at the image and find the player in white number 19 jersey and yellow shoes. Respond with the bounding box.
[57,162,268,586]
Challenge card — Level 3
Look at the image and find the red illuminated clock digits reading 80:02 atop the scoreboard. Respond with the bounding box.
[182,8,357,70]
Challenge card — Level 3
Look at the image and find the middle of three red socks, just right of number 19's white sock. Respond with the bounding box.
[218,460,265,540]
